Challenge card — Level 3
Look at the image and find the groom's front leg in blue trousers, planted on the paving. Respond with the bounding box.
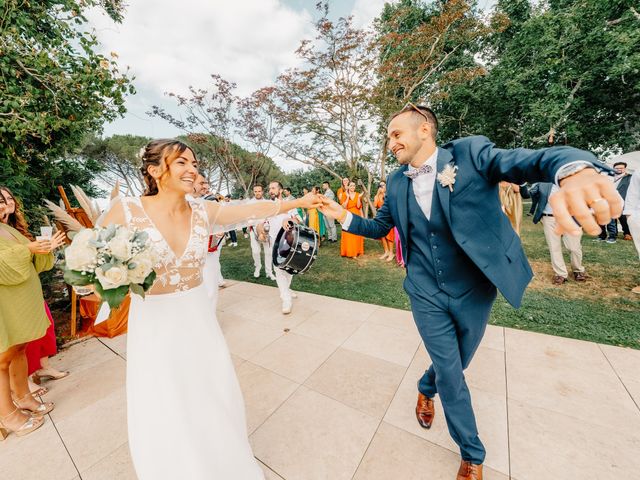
[411,292,485,464]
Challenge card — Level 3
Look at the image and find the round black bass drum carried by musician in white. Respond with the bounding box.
[272,223,318,275]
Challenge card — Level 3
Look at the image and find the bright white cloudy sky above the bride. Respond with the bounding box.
[89,0,385,142]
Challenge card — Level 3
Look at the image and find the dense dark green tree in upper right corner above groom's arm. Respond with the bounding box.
[455,0,640,151]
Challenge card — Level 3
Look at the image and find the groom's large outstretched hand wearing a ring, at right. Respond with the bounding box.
[549,168,624,235]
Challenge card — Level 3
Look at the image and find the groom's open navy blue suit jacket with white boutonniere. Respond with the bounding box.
[348,136,598,308]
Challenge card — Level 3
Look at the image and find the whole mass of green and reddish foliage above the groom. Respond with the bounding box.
[376,0,640,151]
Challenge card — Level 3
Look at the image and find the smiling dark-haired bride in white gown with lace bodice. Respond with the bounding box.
[100,140,321,480]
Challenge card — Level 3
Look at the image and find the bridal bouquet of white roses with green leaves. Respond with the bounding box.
[64,225,158,308]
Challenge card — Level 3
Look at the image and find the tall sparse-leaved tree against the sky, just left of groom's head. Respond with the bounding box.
[272,2,378,206]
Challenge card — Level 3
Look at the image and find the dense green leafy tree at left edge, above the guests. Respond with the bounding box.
[0,0,134,217]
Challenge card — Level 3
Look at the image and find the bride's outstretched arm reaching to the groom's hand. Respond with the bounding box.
[205,193,322,233]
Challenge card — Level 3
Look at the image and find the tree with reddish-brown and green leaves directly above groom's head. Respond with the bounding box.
[374,0,492,143]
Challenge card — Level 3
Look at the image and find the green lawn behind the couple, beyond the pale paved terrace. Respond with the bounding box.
[222,209,640,349]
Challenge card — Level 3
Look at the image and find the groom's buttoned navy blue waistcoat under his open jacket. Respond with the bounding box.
[405,182,489,298]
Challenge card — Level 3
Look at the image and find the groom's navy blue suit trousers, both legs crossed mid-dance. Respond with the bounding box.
[409,283,497,464]
